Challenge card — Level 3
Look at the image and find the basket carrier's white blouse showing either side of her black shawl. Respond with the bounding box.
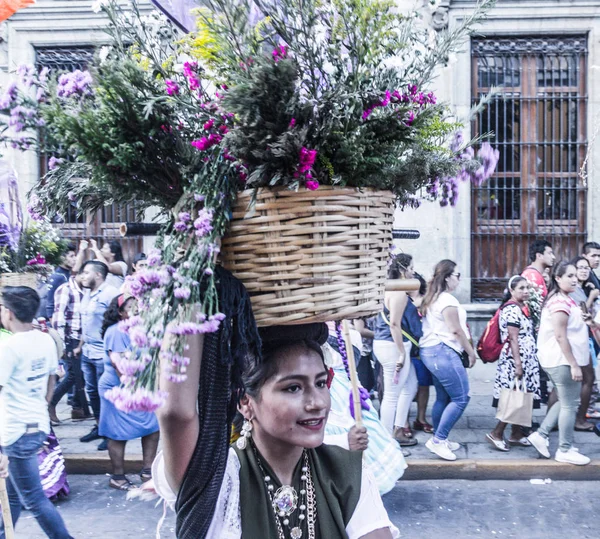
[152,448,242,539]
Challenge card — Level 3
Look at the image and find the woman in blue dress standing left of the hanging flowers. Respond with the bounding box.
[98,294,159,490]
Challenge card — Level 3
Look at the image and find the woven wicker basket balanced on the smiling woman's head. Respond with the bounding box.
[221,187,394,326]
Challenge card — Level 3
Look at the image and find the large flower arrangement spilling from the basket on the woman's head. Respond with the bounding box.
[0,0,497,410]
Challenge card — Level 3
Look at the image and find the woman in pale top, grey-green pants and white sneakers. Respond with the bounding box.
[528,261,591,465]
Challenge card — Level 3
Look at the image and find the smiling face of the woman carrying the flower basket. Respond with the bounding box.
[240,345,331,449]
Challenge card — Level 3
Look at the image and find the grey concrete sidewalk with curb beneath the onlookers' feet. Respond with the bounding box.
[54,362,600,480]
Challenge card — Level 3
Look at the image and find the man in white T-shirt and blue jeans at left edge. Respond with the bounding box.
[0,286,72,539]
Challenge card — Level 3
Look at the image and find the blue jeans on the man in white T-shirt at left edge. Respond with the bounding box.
[0,431,72,539]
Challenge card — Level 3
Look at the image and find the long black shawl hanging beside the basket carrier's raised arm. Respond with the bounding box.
[175,267,261,539]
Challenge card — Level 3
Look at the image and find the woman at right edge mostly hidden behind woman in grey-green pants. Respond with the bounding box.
[569,256,599,432]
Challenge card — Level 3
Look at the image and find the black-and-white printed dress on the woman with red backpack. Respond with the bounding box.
[493,304,540,408]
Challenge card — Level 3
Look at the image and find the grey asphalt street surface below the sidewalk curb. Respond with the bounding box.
[11,475,599,539]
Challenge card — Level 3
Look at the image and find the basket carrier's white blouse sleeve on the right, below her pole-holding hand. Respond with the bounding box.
[346,467,400,539]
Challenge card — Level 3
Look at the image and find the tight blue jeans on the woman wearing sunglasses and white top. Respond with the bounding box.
[420,344,471,440]
